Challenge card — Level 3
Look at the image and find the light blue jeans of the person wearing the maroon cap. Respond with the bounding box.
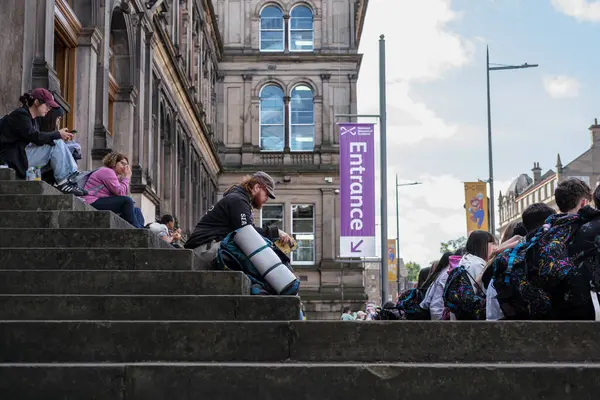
[25,140,77,183]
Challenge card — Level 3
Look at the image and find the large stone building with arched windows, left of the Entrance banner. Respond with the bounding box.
[0,0,367,318]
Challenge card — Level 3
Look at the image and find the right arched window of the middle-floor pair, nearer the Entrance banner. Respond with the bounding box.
[290,85,315,151]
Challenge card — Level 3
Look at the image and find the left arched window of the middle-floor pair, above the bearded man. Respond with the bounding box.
[260,85,285,151]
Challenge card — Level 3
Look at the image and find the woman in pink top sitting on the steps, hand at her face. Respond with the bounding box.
[83,152,136,226]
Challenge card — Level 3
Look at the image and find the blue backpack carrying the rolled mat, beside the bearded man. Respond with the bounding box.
[215,227,300,296]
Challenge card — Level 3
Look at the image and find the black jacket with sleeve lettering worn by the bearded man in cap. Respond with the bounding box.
[185,186,279,249]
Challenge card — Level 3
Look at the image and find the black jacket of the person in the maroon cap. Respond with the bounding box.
[0,107,61,178]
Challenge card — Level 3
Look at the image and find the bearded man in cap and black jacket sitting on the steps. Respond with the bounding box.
[185,171,292,269]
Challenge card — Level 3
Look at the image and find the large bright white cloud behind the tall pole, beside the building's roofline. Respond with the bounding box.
[358,0,475,145]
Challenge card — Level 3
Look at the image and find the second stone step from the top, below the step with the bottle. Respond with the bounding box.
[0,194,88,211]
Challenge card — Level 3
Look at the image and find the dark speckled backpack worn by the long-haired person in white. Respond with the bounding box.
[443,265,486,321]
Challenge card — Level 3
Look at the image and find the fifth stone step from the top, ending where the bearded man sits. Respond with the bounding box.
[0,248,200,271]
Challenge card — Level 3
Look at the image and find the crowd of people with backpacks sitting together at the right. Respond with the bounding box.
[410,178,600,320]
